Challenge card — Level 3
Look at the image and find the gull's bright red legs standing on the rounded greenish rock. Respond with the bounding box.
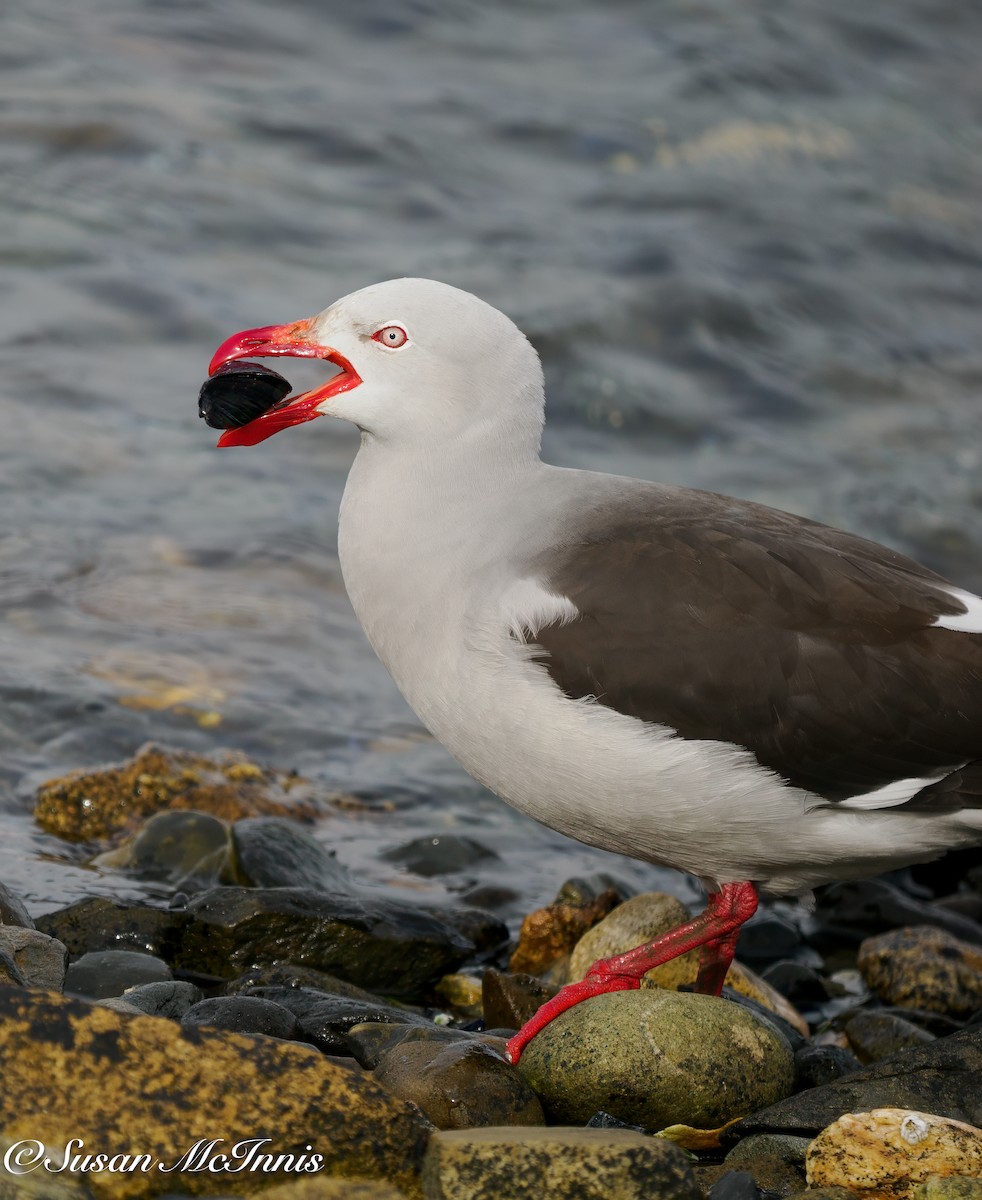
[508,883,758,1062]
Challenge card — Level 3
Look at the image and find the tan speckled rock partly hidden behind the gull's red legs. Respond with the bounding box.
[569,892,808,1037]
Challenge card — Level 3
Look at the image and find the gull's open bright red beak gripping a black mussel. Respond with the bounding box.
[208,318,361,446]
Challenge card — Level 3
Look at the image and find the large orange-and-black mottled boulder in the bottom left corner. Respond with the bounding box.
[0,989,430,1200]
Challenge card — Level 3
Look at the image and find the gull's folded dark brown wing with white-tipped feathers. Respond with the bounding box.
[527,490,982,800]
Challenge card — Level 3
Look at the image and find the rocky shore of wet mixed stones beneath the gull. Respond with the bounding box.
[0,746,982,1200]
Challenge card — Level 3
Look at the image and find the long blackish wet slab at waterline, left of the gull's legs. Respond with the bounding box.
[181,888,474,998]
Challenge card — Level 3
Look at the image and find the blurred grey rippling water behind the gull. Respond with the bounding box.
[0,0,982,916]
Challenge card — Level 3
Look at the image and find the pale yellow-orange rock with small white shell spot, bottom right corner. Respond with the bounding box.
[807,1108,982,1200]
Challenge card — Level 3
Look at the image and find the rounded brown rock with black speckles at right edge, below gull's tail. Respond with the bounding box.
[857,925,982,1016]
